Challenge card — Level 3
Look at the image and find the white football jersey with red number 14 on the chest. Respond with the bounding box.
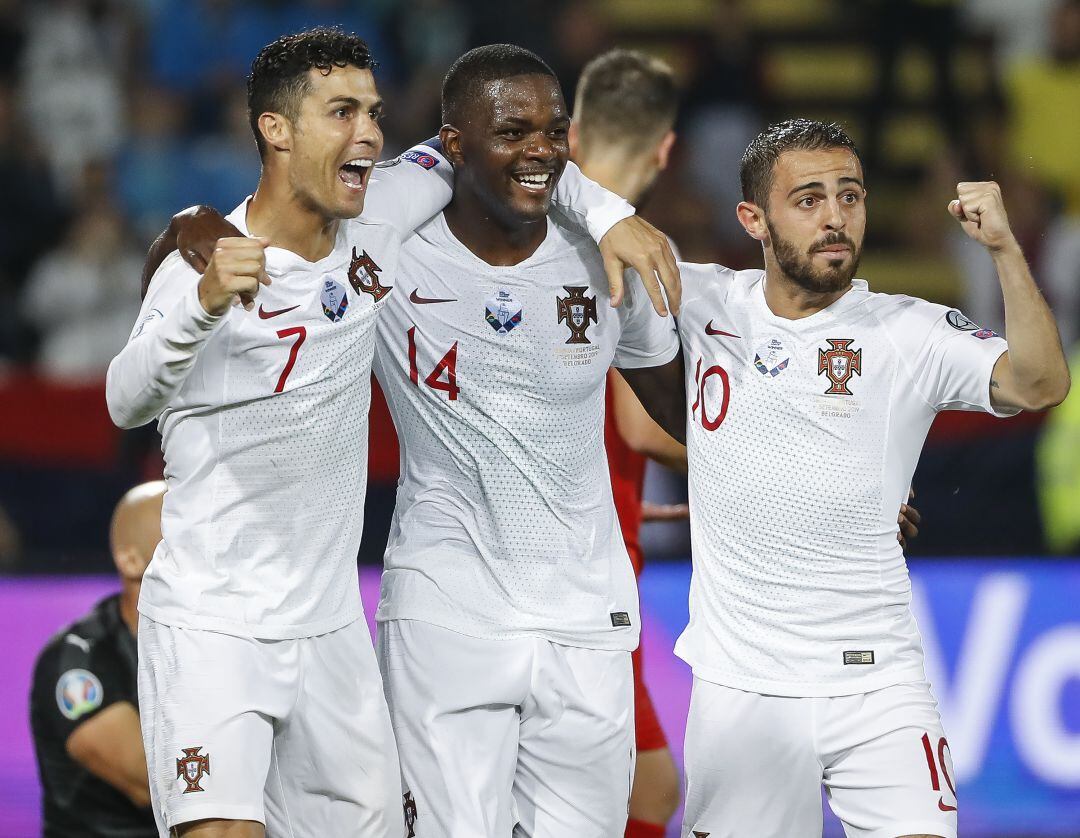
[375,215,678,649]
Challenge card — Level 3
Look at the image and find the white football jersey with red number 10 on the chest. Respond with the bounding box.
[675,265,1008,697]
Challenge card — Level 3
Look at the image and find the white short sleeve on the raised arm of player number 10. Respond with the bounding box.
[890,298,1018,417]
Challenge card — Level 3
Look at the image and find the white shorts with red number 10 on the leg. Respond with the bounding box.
[683,678,956,838]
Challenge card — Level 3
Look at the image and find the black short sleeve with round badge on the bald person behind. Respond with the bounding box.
[35,634,135,741]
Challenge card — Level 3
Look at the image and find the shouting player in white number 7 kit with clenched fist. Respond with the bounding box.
[118,29,667,836]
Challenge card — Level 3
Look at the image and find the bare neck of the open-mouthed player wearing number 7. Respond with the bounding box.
[246,173,340,261]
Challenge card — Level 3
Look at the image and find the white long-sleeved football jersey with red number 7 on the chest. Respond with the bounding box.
[107,149,451,639]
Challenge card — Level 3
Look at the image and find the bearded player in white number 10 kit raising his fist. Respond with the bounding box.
[676,120,1069,838]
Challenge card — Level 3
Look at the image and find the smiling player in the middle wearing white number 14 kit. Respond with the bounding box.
[375,44,683,838]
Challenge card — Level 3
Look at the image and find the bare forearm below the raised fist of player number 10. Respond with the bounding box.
[990,243,1069,407]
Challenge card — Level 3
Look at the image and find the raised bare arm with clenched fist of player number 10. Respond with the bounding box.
[948,181,1069,410]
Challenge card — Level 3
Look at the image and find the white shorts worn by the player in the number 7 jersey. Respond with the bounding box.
[138,617,404,838]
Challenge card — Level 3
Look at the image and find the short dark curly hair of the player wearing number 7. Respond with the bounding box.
[247,26,375,156]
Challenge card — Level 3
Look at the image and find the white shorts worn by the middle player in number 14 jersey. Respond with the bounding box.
[378,620,634,838]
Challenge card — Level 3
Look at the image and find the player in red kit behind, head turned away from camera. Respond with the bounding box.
[569,50,687,838]
